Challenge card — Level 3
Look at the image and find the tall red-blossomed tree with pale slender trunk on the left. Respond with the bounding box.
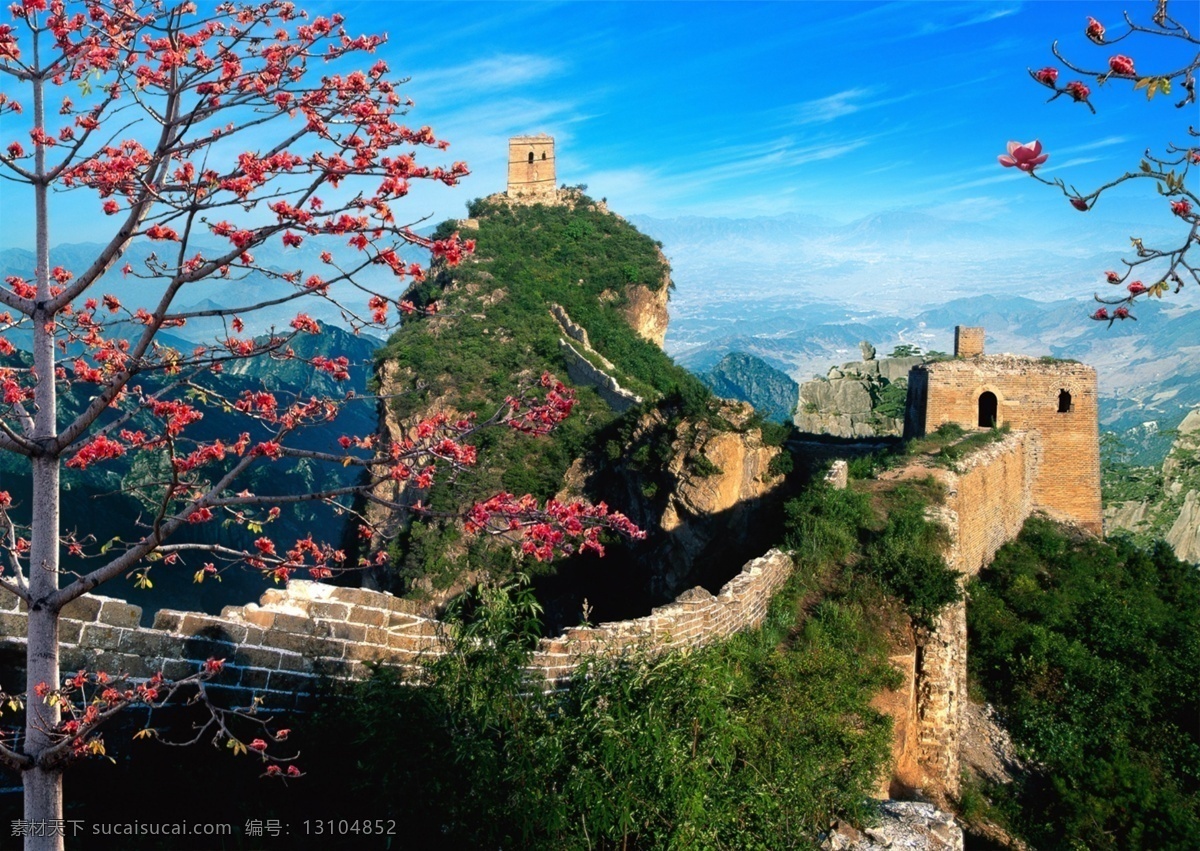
[0,0,637,847]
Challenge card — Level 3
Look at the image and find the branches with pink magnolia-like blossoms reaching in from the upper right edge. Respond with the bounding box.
[1000,0,1200,325]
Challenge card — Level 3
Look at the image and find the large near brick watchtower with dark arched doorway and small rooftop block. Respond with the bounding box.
[905,326,1103,534]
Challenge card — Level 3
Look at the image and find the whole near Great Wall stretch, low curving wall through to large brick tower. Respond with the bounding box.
[0,324,1099,796]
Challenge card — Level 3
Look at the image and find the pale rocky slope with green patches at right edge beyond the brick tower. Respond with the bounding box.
[1104,409,1200,563]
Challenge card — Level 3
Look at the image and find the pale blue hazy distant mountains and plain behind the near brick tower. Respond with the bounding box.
[632,210,1200,439]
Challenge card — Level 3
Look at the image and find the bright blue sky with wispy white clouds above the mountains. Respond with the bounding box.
[0,0,1200,245]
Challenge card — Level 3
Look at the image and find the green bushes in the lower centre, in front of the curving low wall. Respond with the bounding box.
[300,489,916,849]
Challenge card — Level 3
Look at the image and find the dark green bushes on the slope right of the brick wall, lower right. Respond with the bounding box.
[967,519,1200,851]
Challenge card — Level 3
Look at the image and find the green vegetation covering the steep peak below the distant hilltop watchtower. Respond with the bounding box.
[379,196,710,591]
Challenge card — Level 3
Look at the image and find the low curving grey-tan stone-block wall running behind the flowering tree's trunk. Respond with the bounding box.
[0,550,792,711]
